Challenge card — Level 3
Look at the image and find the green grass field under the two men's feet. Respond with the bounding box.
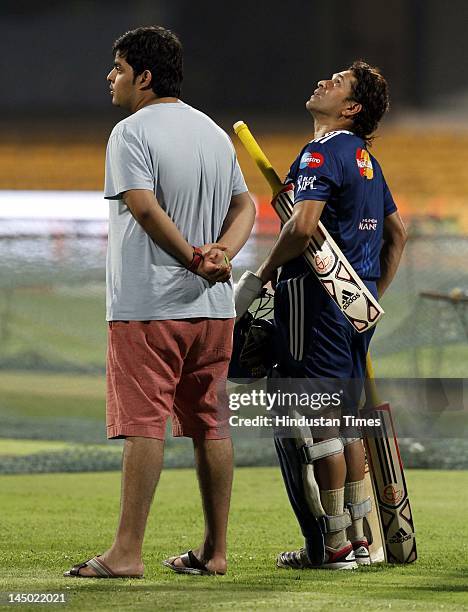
[0,468,468,612]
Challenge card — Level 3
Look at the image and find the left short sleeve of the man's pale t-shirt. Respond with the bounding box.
[104,124,155,200]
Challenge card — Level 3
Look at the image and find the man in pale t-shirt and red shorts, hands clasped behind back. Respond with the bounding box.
[65,27,255,577]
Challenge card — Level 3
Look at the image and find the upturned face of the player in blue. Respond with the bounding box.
[306,70,356,117]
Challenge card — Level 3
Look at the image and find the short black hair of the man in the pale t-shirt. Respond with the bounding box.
[112,26,183,98]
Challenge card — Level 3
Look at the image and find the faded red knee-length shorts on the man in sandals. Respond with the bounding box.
[107,318,234,440]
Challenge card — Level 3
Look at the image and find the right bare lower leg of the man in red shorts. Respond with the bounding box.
[174,438,233,573]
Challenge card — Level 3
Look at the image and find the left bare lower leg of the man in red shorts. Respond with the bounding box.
[80,437,164,576]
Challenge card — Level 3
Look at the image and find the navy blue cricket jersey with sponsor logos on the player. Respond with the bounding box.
[281,130,397,280]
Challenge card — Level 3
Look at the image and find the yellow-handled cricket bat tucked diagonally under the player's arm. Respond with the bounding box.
[234,121,384,332]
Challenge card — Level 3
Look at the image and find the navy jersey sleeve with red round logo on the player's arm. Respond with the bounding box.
[291,142,343,203]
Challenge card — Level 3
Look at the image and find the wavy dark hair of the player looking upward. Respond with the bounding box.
[348,60,389,145]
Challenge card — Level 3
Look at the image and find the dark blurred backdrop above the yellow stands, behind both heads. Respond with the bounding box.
[0,0,468,128]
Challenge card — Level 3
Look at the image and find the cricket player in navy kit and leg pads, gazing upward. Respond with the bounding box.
[257,61,406,569]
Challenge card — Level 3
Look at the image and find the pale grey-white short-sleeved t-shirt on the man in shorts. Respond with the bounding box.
[104,102,247,321]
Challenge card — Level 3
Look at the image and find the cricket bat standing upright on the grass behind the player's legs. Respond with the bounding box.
[359,354,417,563]
